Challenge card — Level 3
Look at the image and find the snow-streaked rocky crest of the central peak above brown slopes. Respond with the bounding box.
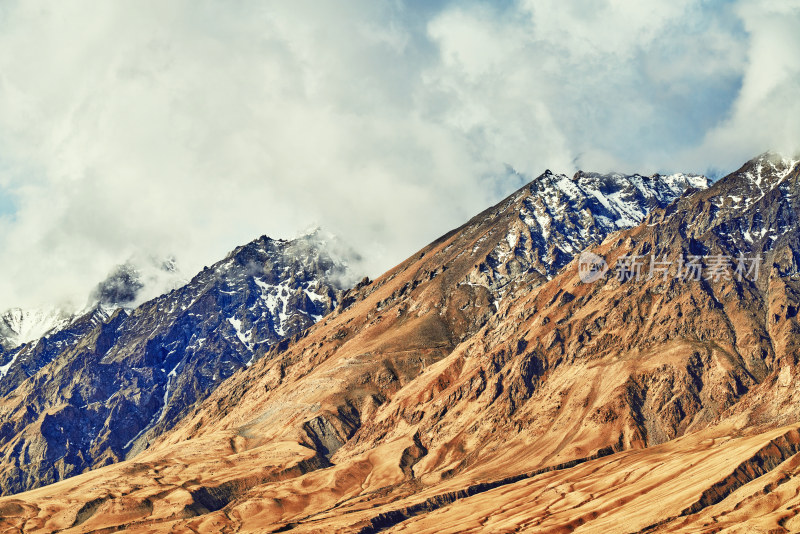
[464,170,710,300]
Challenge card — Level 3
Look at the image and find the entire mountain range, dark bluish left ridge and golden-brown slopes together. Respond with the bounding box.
[0,154,800,533]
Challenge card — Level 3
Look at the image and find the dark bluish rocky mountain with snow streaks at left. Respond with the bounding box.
[0,232,349,493]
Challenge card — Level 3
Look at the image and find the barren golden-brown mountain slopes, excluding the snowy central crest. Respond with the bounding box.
[0,157,800,532]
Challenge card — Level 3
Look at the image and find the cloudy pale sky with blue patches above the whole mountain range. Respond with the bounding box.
[0,0,800,309]
